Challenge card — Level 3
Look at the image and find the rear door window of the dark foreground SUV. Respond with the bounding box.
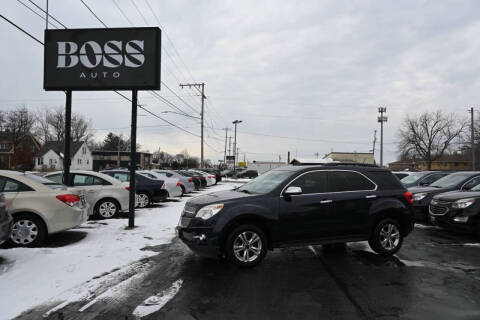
[328,171,375,192]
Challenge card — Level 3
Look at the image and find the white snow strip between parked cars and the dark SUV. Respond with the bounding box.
[0,183,237,319]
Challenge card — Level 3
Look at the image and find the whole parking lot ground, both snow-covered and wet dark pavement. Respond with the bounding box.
[0,183,480,319]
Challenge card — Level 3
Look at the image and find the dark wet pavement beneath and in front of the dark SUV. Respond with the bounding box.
[18,226,480,320]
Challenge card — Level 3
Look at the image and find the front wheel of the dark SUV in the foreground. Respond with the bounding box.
[225,224,268,268]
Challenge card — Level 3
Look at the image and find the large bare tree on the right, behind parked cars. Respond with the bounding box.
[398,110,467,170]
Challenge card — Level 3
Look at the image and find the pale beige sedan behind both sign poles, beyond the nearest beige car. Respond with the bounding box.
[45,170,129,218]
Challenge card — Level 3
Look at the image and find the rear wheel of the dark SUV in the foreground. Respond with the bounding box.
[368,218,403,256]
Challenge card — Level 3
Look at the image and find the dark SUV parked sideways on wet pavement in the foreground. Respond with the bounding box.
[177,164,413,267]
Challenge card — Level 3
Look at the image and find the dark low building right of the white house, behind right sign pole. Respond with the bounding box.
[92,150,153,171]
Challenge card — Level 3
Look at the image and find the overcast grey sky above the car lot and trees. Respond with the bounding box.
[0,0,480,162]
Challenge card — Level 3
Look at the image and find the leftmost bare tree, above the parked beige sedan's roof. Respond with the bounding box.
[5,105,35,169]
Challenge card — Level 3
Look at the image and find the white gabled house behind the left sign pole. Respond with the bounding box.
[35,141,93,171]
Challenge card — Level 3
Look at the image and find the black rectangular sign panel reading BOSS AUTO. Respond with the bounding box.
[43,28,161,90]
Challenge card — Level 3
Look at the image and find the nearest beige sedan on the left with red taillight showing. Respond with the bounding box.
[0,170,89,247]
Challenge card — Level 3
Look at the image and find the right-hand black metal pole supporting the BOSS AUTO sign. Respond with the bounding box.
[128,90,138,228]
